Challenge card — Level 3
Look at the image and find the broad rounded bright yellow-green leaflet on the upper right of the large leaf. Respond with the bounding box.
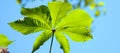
[56,9,92,30]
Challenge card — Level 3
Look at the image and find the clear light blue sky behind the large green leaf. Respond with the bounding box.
[0,0,120,53]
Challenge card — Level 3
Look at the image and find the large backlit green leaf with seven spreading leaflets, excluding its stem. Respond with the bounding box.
[9,0,93,53]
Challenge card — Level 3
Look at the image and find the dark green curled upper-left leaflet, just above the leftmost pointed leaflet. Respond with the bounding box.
[21,5,52,29]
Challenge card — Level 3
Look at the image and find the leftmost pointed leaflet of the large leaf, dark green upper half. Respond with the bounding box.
[9,17,48,35]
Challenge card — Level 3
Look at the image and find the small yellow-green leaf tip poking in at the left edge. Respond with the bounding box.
[0,34,12,47]
